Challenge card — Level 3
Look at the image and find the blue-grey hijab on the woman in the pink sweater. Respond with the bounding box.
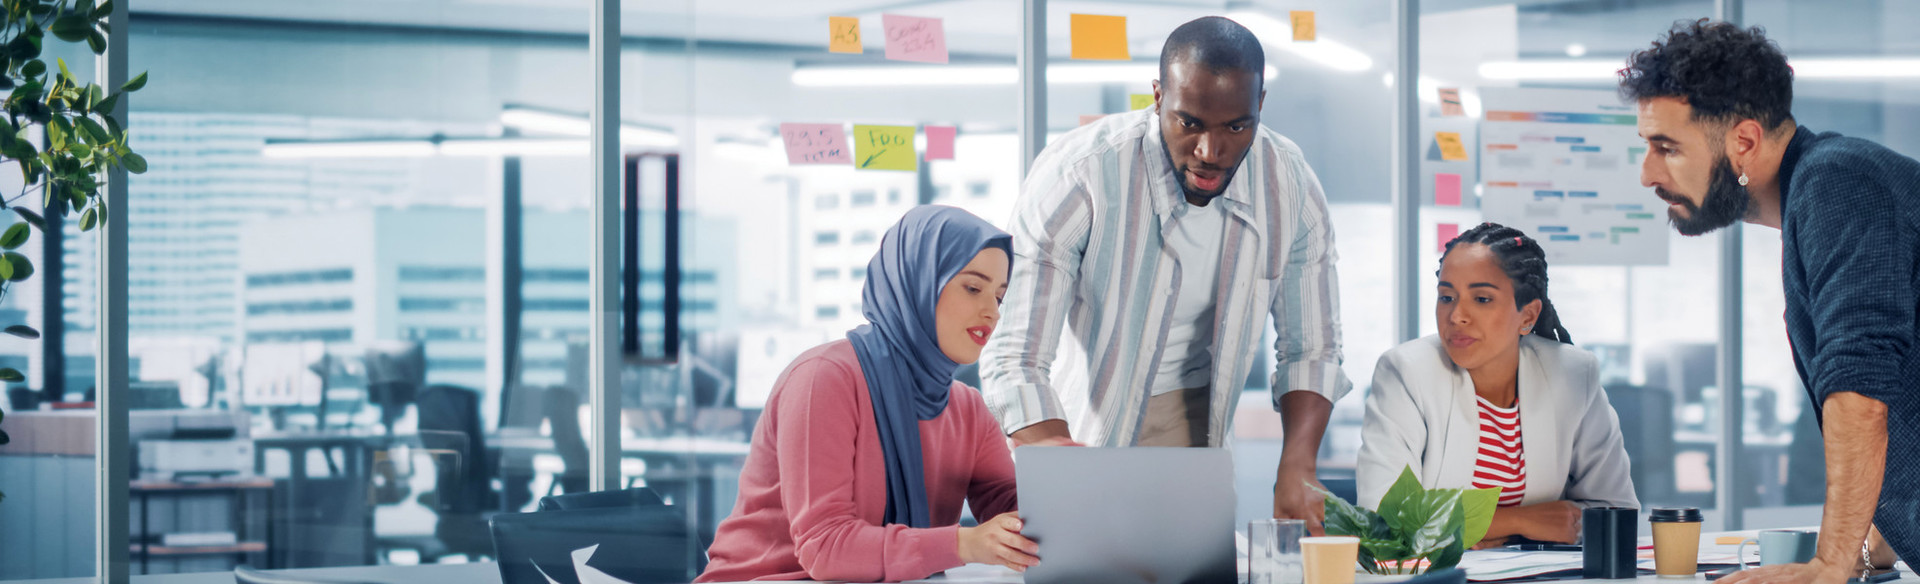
[847,206,1014,528]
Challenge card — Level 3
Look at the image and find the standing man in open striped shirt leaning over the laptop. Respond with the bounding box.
[981,17,1352,532]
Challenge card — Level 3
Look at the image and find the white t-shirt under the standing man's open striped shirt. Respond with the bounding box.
[1154,198,1227,396]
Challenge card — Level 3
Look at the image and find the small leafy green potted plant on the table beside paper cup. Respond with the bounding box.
[1309,467,1500,574]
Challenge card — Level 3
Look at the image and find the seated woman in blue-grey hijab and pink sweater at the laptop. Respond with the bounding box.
[699,206,1039,582]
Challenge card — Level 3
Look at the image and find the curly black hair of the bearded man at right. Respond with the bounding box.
[1620,19,1793,131]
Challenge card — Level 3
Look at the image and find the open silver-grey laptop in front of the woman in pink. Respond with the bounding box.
[1014,446,1238,584]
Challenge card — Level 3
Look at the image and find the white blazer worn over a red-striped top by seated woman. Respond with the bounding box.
[1357,334,1640,507]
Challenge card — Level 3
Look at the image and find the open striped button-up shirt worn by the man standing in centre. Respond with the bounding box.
[979,108,1354,446]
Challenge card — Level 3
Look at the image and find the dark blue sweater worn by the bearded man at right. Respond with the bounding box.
[1780,129,1920,565]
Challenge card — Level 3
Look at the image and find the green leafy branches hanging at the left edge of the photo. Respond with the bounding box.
[0,0,146,503]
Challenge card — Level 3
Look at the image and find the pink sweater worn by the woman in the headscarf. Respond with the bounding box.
[695,340,1016,582]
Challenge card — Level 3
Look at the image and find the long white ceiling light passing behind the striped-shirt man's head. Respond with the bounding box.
[791,63,1281,86]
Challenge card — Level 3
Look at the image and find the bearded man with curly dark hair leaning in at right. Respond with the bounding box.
[1620,19,1920,584]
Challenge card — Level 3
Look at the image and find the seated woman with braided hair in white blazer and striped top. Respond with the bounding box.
[1357,223,1640,546]
